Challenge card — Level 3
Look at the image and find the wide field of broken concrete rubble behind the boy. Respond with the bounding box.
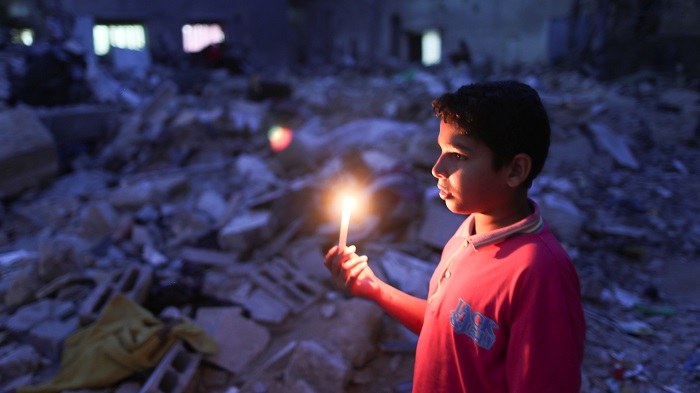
[0,62,700,393]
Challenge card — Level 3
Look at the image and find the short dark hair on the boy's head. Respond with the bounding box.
[433,81,551,187]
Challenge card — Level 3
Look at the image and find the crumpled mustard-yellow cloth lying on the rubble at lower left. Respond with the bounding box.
[17,294,217,393]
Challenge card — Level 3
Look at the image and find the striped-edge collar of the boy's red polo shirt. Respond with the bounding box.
[456,199,544,250]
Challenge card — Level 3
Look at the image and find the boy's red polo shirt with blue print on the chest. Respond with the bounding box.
[413,201,586,393]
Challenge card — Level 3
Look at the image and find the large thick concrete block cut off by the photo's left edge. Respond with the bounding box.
[0,106,58,198]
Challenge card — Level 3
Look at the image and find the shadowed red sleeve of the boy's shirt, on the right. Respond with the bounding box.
[506,248,585,393]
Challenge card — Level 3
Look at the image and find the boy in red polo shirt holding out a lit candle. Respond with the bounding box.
[324,81,585,393]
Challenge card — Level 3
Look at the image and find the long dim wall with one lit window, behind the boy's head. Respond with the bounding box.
[292,0,700,77]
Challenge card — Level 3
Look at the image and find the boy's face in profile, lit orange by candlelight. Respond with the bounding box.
[432,121,512,215]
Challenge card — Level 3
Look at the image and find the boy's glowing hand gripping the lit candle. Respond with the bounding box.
[323,245,381,300]
